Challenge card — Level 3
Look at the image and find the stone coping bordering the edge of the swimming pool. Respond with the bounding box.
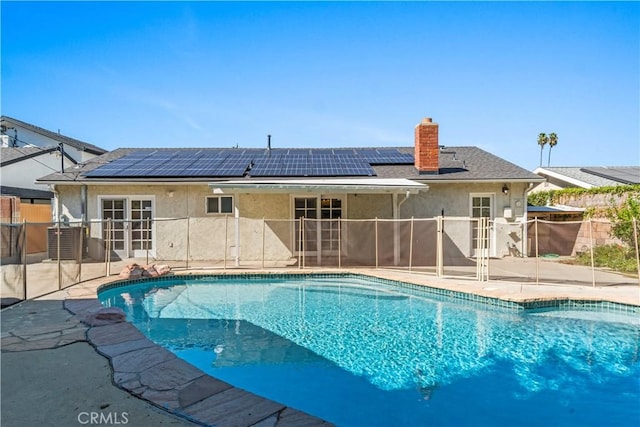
[51,270,640,427]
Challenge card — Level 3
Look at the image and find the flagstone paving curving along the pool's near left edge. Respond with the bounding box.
[2,279,330,427]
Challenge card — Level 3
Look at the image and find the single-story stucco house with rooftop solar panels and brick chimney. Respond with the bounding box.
[38,119,543,265]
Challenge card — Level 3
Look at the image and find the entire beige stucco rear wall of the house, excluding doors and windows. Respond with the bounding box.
[58,183,526,261]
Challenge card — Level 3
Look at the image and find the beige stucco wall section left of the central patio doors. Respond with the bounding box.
[58,184,300,262]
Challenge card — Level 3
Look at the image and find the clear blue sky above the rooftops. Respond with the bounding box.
[0,1,640,170]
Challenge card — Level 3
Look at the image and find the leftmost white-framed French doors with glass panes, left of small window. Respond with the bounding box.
[100,197,155,259]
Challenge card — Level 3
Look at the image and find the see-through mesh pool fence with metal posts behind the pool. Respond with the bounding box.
[0,216,640,303]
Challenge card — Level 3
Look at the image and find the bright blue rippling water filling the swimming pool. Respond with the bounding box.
[99,276,640,426]
